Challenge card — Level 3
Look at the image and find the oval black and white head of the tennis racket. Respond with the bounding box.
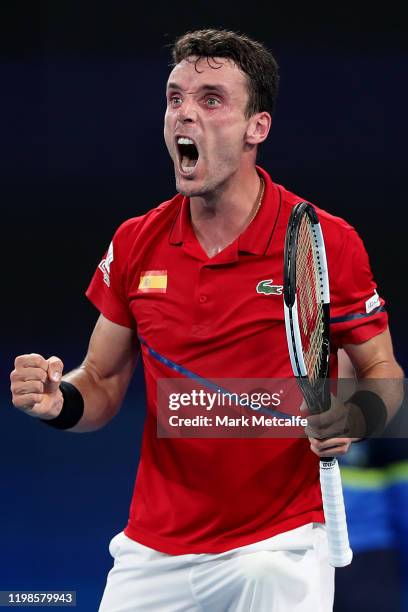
[284,202,330,413]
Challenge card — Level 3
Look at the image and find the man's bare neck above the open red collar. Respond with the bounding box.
[190,168,264,257]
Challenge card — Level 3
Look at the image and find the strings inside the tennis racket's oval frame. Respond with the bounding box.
[296,215,324,382]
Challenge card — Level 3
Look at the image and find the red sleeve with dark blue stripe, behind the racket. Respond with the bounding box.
[328,228,388,348]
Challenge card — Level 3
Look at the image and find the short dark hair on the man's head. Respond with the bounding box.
[172,29,279,117]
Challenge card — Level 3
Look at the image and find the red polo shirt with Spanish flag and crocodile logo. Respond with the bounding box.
[87,168,387,554]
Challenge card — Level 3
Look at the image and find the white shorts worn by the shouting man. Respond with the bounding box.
[99,523,334,612]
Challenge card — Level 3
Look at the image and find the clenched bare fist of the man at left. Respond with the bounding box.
[10,353,64,419]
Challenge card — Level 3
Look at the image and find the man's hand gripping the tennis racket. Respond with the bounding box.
[305,395,365,457]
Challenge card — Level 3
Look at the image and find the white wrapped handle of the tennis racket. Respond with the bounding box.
[320,457,353,567]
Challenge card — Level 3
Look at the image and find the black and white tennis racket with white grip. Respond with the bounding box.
[284,202,353,567]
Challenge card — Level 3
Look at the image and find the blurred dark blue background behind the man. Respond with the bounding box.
[0,0,408,612]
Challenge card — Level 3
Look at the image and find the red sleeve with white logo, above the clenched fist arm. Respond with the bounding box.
[85,224,135,329]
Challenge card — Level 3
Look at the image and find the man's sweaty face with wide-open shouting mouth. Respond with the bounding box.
[164,58,248,196]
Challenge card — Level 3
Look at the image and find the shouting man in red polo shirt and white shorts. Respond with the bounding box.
[11,30,401,612]
